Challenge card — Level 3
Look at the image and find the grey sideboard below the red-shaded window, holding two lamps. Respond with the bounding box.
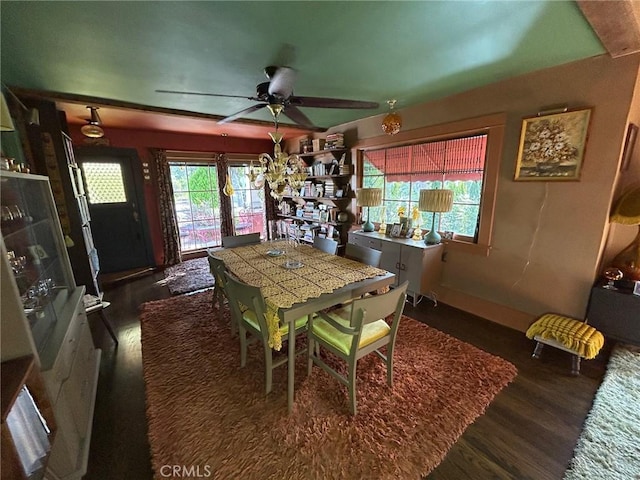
[349,231,444,306]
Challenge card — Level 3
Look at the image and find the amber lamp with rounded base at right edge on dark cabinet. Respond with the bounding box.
[610,188,640,281]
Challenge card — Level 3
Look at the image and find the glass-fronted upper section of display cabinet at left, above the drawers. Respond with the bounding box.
[0,171,79,370]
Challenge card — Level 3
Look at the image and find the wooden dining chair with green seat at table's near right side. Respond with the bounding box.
[307,282,409,415]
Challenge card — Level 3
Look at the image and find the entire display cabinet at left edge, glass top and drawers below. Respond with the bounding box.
[0,171,101,479]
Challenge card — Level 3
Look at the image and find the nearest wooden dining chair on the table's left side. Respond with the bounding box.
[224,272,308,395]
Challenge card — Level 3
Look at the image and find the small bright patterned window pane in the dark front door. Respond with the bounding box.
[82,162,127,205]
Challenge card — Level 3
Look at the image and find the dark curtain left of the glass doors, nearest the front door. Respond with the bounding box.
[152,149,182,267]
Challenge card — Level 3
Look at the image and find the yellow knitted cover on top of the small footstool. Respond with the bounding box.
[527,313,604,359]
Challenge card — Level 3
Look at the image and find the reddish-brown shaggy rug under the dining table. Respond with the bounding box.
[140,292,517,480]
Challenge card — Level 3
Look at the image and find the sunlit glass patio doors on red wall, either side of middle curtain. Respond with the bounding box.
[167,151,266,253]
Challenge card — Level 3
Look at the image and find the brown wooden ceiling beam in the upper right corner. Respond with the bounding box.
[577,0,640,58]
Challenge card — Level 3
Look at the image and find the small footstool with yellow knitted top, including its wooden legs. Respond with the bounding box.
[526,313,604,375]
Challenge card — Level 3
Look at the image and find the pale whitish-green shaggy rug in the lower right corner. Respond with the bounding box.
[564,345,640,480]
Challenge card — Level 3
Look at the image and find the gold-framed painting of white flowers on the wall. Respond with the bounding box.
[514,108,592,182]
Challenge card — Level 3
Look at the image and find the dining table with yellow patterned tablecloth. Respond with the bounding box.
[210,240,395,412]
